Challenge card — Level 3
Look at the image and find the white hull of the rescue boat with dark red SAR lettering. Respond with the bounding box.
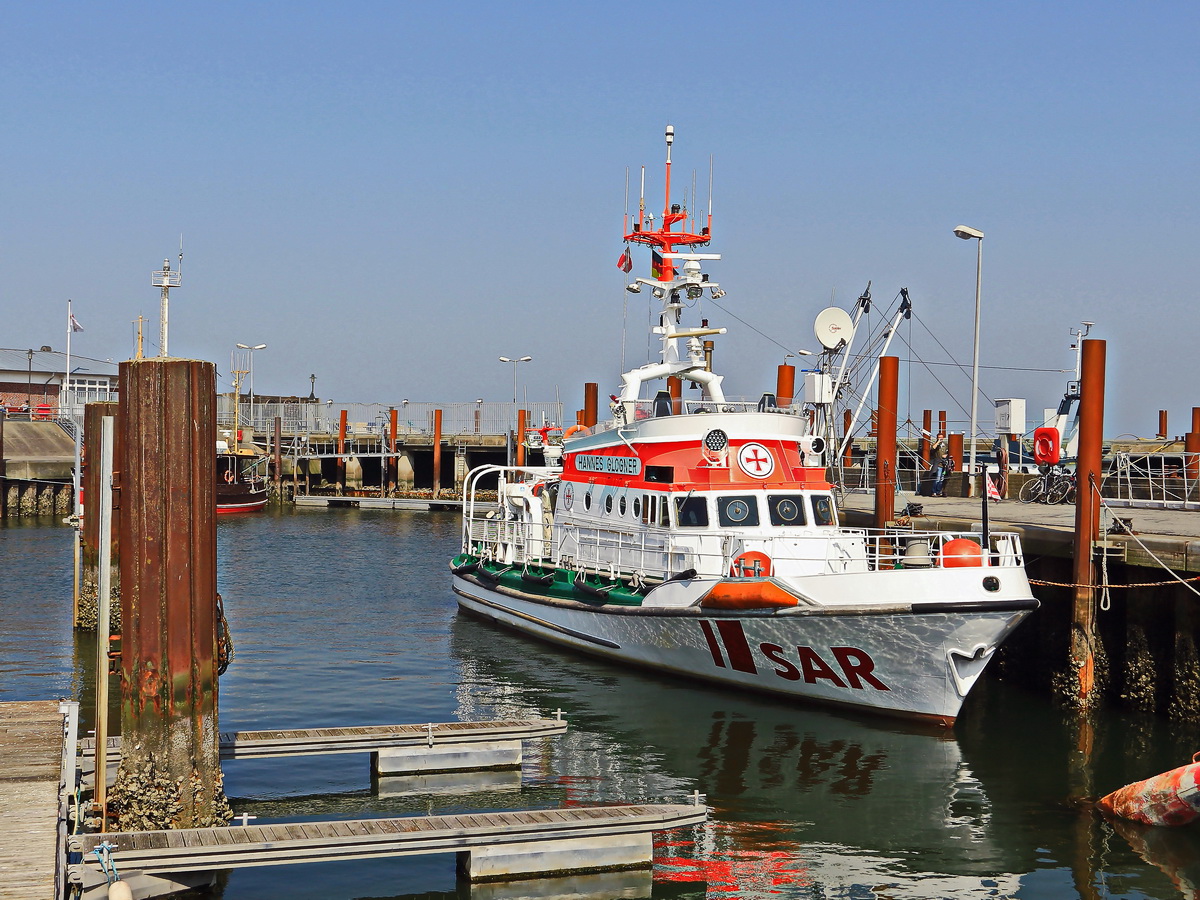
[454,574,1037,725]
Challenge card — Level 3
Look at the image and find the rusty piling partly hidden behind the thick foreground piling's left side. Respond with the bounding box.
[74,401,124,631]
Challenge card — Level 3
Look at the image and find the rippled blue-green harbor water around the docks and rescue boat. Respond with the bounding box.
[7,510,1200,900]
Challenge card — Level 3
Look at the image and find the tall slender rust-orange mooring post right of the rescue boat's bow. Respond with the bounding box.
[1070,340,1106,708]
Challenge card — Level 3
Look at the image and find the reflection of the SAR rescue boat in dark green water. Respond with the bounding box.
[451,617,1019,898]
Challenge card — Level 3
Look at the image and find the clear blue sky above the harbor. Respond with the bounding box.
[0,2,1200,436]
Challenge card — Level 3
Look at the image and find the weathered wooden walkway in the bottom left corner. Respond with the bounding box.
[0,700,74,900]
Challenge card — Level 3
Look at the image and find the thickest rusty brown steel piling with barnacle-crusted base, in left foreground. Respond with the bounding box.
[110,358,232,832]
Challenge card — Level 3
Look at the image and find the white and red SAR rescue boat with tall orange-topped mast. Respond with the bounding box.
[451,126,1038,724]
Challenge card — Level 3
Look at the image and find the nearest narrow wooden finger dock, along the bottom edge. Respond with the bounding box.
[70,802,708,899]
